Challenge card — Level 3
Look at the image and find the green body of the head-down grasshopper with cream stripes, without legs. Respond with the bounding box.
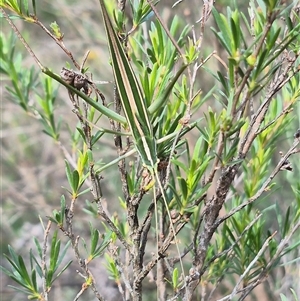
[99,0,158,168]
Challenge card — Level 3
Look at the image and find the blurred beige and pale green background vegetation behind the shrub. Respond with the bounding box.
[0,0,300,301]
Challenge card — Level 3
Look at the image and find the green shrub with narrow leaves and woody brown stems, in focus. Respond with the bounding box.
[0,0,300,301]
